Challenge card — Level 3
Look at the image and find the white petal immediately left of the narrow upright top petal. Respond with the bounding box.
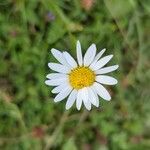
[63,52,77,68]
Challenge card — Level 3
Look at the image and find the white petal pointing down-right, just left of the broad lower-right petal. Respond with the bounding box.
[88,87,99,107]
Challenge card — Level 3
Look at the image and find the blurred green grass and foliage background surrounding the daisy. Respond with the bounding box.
[0,0,150,150]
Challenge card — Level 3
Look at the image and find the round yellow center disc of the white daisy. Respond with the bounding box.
[69,67,95,89]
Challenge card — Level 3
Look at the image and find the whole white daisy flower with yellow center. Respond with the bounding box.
[45,41,119,110]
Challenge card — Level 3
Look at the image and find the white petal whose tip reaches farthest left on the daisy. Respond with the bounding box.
[45,78,67,86]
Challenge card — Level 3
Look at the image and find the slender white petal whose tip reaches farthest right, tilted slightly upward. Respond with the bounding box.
[95,65,119,74]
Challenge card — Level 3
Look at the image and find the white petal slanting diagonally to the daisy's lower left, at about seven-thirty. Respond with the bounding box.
[54,86,72,102]
